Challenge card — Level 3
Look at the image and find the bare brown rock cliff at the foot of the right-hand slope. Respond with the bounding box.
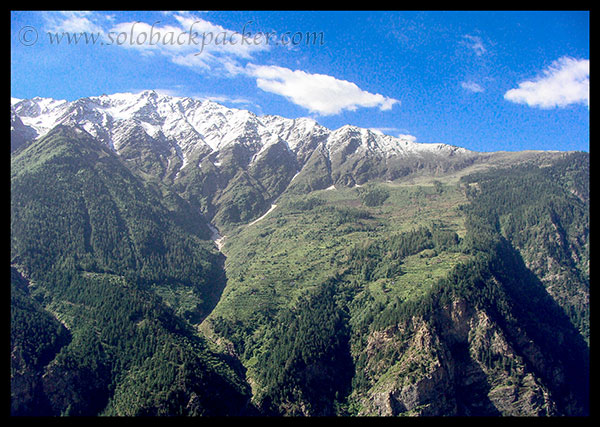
[361,299,556,416]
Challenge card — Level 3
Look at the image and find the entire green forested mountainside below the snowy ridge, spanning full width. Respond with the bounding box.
[11,127,590,415]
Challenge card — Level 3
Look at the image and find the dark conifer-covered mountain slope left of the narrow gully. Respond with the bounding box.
[11,128,249,415]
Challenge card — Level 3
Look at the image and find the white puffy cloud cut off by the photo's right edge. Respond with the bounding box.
[504,56,590,109]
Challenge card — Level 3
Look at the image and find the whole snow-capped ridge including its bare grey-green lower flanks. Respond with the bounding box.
[11,91,478,226]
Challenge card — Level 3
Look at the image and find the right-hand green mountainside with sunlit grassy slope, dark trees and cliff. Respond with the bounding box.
[206,154,589,415]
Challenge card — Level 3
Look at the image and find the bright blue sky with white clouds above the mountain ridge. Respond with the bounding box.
[11,11,589,151]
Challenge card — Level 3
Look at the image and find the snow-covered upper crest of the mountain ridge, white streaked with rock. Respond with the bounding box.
[12,91,468,173]
